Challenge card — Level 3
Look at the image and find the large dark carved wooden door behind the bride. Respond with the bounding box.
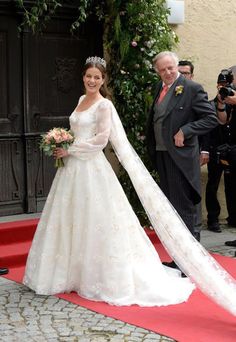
[0,3,102,216]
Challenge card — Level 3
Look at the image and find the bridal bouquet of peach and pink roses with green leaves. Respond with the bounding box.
[39,127,74,167]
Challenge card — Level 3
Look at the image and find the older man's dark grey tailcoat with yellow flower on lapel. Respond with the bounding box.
[146,75,218,203]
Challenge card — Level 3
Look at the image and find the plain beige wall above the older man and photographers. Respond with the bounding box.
[173,0,236,98]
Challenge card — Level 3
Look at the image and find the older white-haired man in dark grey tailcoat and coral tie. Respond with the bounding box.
[147,51,218,267]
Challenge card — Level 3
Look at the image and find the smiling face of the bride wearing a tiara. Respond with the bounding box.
[83,67,104,94]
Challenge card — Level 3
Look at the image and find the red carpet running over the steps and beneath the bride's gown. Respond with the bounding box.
[0,220,236,342]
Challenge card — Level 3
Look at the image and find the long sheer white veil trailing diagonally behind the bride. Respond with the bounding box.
[109,106,236,315]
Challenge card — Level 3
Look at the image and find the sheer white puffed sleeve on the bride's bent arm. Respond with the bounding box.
[68,101,112,159]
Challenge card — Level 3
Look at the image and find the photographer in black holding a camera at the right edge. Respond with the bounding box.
[206,69,236,234]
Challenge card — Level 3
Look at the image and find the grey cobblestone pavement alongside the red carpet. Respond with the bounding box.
[0,226,236,342]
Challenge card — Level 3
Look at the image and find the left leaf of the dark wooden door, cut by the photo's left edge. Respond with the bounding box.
[0,14,25,216]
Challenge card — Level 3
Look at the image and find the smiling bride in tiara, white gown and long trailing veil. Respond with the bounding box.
[23,57,236,315]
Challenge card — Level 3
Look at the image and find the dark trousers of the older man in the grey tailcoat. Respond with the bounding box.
[156,151,200,239]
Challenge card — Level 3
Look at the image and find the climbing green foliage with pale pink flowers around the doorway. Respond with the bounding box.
[18,0,177,224]
